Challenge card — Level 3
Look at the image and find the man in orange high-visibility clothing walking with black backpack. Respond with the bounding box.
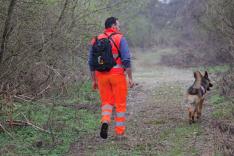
[88,17,134,139]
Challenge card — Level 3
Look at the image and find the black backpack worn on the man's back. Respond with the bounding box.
[91,33,120,72]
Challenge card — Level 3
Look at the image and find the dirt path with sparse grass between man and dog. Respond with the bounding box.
[70,49,214,156]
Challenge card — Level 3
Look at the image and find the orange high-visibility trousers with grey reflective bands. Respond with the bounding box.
[97,73,127,135]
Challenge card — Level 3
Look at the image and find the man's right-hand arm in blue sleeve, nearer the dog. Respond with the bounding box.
[120,37,134,87]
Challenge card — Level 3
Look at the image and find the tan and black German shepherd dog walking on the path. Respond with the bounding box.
[185,71,213,124]
